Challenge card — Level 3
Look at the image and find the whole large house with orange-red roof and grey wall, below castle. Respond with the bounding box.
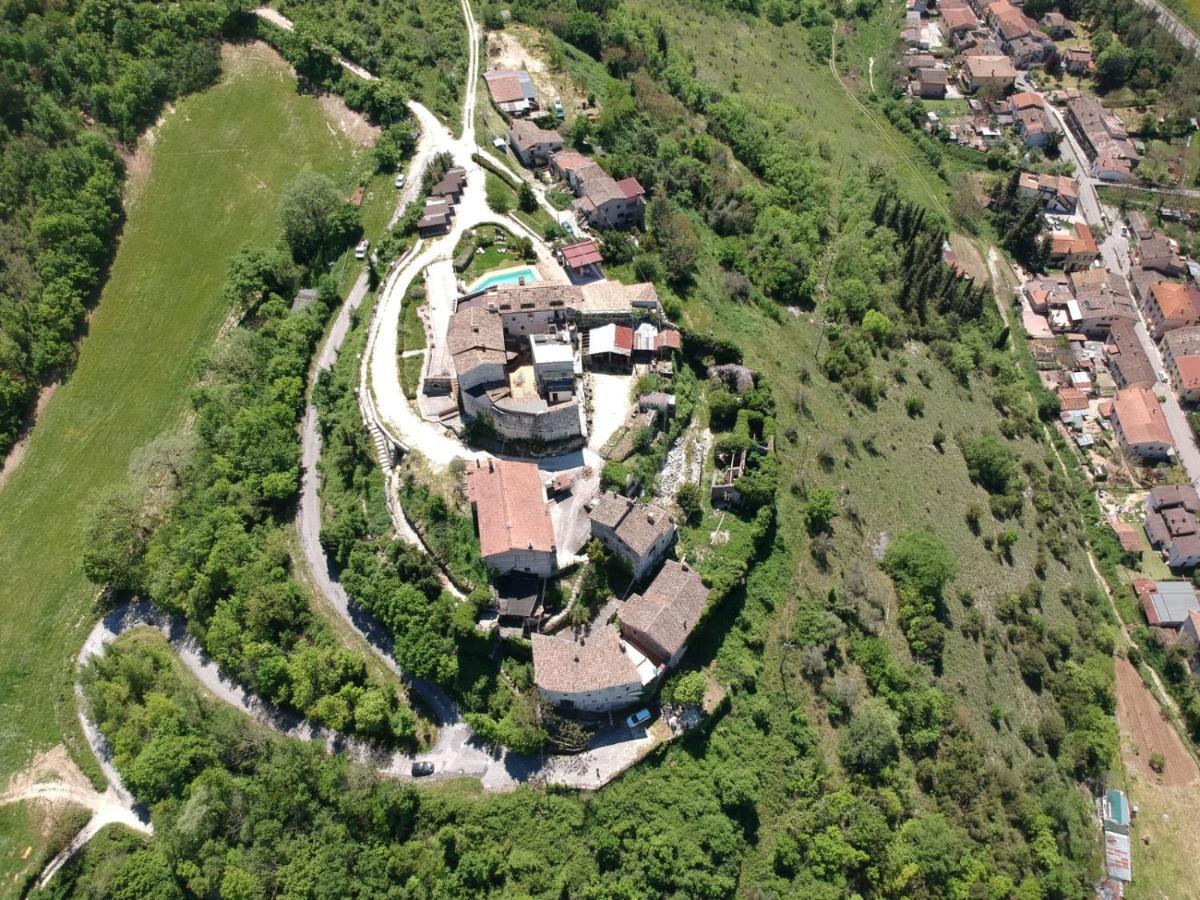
[467,457,558,578]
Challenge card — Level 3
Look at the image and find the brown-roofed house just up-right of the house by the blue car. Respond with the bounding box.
[617,559,708,670]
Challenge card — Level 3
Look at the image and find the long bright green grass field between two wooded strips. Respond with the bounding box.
[0,48,355,796]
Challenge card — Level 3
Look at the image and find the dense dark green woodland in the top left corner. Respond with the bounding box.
[0,0,240,457]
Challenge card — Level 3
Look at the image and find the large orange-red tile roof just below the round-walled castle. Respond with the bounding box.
[467,458,556,559]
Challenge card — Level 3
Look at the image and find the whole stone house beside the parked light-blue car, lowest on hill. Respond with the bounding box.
[529,625,658,714]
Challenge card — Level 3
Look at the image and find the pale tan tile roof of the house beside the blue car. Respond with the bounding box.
[529,625,641,694]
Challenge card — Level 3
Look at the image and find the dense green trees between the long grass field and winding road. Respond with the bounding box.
[84,237,415,740]
